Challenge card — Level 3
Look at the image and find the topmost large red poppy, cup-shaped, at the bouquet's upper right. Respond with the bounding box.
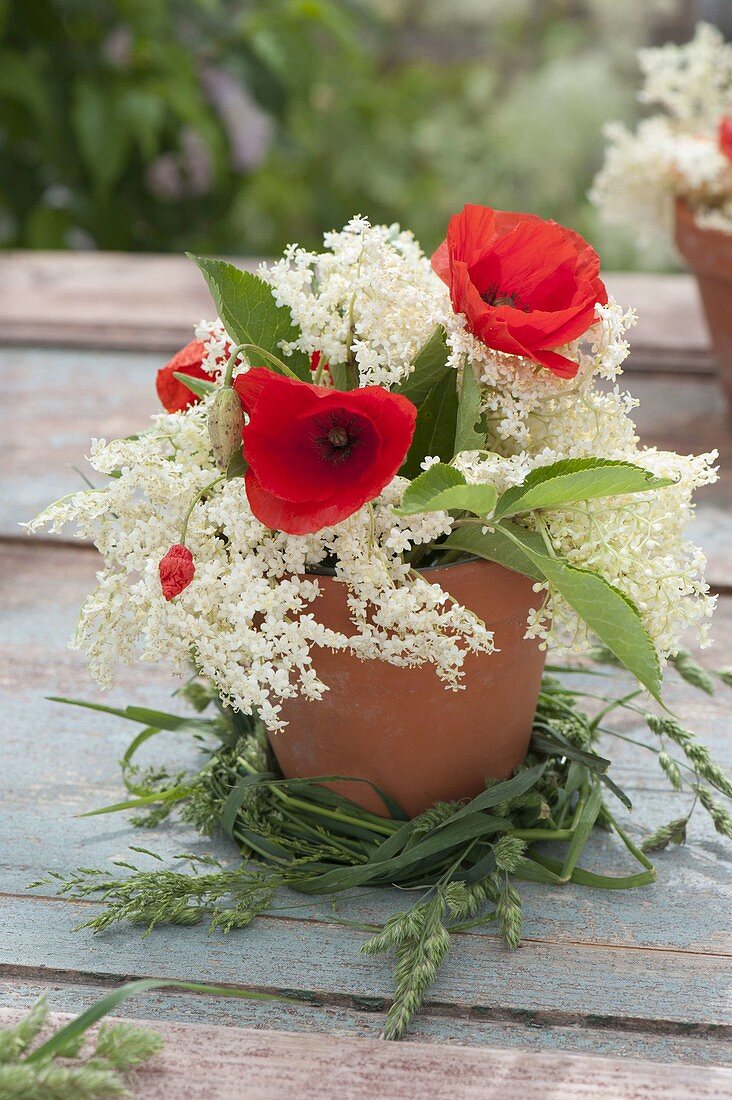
[433,206,608,378]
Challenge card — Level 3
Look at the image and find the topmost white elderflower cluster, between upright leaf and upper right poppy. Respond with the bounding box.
[260,217,446,386]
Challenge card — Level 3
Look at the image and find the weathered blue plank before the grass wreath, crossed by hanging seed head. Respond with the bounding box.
[0,897,732,1033]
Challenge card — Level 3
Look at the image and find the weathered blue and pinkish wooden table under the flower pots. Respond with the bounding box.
[0,253,732,1100]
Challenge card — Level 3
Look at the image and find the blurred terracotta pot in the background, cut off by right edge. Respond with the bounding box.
[676,199,732,408]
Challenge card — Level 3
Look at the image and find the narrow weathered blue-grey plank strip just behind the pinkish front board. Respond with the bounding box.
[0,978,732,1069]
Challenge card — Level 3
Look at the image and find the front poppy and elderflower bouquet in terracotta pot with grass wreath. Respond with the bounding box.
[31,206,732,1037]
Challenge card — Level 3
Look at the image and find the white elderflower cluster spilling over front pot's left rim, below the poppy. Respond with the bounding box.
[29,400,492,729]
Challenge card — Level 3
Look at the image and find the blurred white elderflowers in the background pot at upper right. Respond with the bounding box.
[590,23,732,241]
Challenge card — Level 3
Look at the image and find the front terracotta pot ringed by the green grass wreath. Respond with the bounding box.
[271,561,545,816]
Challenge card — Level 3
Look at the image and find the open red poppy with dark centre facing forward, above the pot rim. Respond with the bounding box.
[234,366,417,535]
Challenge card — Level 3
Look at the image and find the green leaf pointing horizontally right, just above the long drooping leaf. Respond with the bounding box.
[495,459,674,519]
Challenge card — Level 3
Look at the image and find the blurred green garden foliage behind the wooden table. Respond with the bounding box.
[0,0,732,267]
